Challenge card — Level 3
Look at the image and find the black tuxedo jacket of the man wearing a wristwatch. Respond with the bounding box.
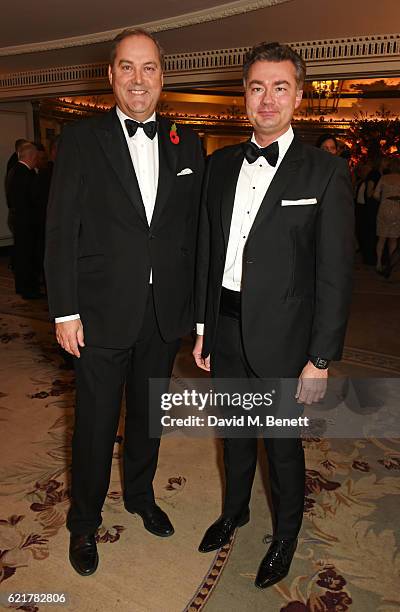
[196,139,354,377]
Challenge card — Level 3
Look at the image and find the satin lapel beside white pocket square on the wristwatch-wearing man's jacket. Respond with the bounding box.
[249,138,303,239]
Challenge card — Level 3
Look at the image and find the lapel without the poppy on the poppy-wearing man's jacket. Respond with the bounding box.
[95,108,148,227]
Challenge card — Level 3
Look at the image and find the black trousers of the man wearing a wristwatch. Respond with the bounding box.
[211,291,305,538]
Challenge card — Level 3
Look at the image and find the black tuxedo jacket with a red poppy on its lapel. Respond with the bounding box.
[45,109,203,348]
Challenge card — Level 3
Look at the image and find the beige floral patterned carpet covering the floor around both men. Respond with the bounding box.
[0,261,400,612]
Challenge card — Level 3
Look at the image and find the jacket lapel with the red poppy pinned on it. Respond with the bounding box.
[151,117,178,227]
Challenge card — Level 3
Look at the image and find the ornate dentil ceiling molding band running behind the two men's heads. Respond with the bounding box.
[0,34,400,100]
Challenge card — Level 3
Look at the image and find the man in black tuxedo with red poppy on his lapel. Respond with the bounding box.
[45,30,203,575]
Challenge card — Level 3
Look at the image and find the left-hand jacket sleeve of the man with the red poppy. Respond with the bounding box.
[45,126,84,318]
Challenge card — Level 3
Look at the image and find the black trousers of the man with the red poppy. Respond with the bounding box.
[67,287,179,534]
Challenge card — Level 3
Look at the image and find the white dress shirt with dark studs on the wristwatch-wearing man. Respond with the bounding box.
[197,126,294,335]
